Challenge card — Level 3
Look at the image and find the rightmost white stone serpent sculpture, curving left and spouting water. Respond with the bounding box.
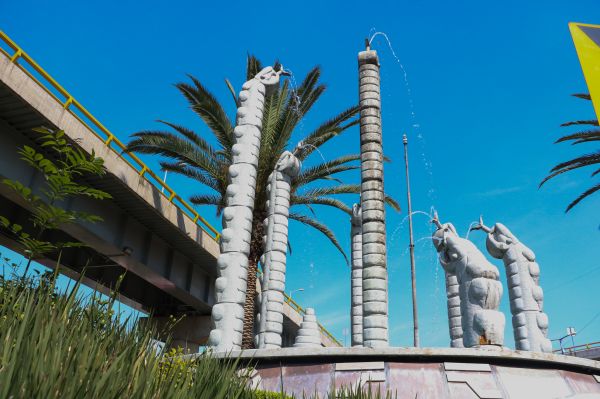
[474,218,552,352]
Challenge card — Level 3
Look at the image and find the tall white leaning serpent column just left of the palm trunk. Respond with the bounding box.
[209,67,281,351]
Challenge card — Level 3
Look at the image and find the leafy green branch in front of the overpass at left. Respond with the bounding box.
[0,128,111,274]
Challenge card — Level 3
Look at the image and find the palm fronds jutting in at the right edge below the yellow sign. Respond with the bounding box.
[540,94,600,212]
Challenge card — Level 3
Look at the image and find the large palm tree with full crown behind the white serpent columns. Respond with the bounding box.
[128,56,399,348]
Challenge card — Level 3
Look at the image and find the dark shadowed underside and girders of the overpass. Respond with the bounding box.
[0,83,215,315]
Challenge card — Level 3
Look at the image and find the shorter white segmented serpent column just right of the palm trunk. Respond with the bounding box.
[258,151,300,348]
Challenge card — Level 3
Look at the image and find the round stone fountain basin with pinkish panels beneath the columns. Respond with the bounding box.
[207,347,600,399]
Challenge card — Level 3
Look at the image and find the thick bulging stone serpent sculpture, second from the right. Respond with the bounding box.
[432,214,505,348]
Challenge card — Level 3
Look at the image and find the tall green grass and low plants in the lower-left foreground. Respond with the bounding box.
[0,274,398,399]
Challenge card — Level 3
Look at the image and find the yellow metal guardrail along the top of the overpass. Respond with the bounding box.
[0,31,220,242]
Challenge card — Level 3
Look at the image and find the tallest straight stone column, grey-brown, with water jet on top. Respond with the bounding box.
[358,47,388,348]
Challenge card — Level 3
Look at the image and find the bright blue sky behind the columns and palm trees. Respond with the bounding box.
[0,0,600,346]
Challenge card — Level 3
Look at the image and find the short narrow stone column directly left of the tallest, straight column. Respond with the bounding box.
[350,204,363,346]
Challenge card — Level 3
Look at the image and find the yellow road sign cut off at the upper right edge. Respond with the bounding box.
[569,22,600,119]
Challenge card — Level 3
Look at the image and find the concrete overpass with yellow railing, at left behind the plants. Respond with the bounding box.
[0,31,340,348]
